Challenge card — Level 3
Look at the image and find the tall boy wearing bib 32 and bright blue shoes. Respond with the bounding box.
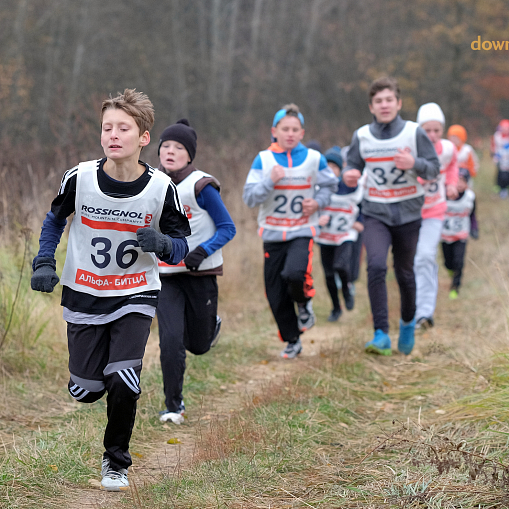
[343,78,440,355]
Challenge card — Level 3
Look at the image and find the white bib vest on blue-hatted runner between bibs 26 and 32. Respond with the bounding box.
[316,175,365,246]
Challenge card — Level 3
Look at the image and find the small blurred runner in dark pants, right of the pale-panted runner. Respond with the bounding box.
[442,168,479,300]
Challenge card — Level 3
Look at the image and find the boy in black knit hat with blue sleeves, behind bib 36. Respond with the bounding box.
[157,119,236,424]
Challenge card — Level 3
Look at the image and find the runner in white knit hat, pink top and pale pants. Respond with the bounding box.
[414,103,458,329]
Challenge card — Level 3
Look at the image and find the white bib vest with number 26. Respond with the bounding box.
[258,149,321,231]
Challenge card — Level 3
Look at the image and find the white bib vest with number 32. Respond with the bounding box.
[357,121,424,203]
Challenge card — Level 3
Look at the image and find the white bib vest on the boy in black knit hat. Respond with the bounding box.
[159,170,223,274]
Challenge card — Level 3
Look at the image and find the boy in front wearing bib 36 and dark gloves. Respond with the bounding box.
[31,89,191,491]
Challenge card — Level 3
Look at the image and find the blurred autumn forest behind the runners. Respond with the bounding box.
[0,0,509,161]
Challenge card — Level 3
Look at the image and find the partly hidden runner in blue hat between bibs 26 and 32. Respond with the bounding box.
[316,147,364,322]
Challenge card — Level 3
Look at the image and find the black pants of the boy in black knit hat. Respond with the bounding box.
[157,273,218,412]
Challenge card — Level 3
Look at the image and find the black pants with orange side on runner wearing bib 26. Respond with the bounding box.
[263,237,315,343]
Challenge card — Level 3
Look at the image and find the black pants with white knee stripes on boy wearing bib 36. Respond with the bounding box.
[67,313,152,470]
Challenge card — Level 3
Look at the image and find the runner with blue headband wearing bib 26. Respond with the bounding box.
[242,104,337,359]
